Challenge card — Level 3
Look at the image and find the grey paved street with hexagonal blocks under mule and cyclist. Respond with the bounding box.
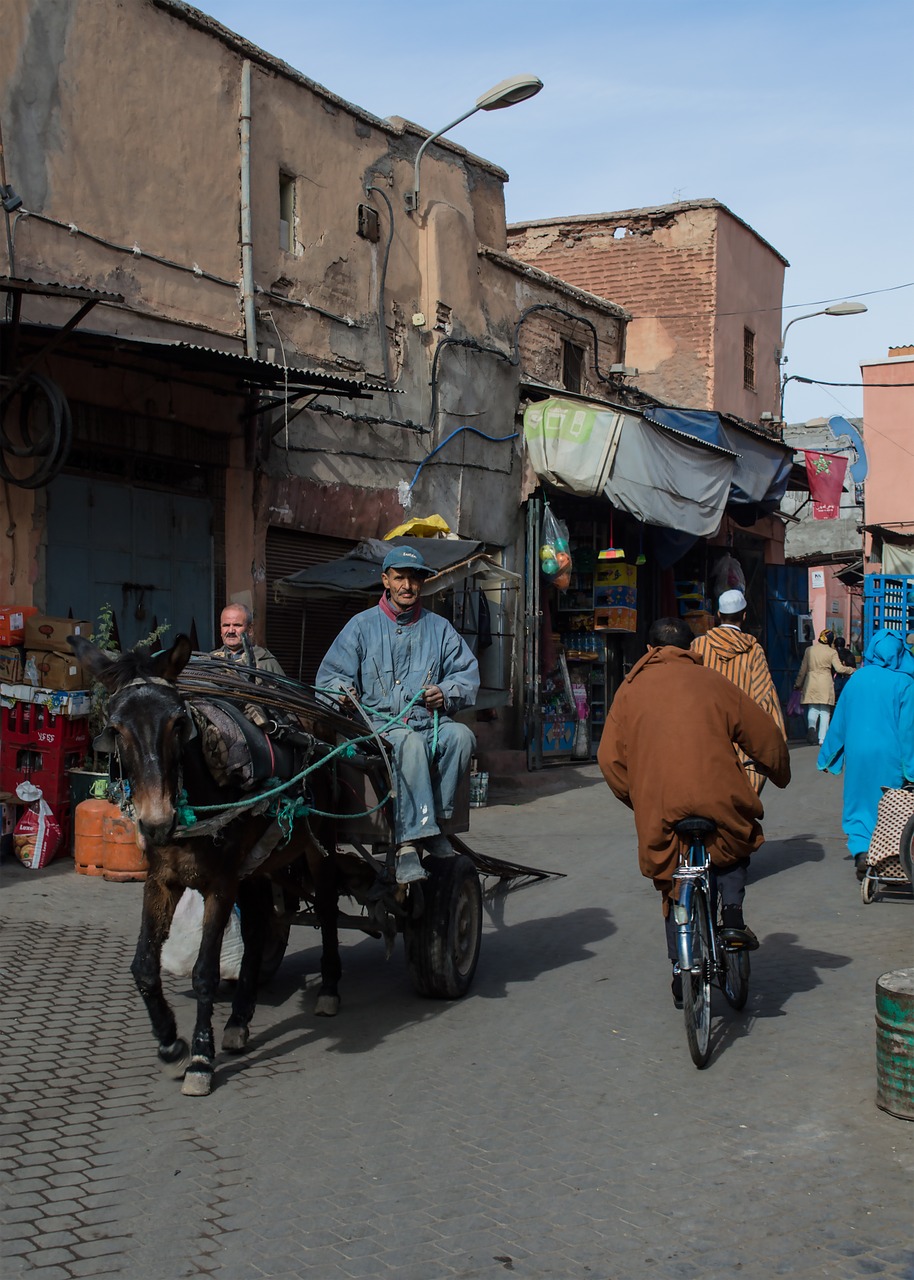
[0,746,914,1280]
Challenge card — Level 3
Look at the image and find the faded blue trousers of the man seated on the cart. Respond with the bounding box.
[383,719,476,845]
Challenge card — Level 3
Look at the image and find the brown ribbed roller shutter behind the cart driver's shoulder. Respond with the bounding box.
[266,529,360,685]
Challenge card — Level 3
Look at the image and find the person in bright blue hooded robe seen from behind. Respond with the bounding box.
[817,628,914,879]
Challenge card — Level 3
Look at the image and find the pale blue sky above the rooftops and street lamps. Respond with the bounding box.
[198,0,914,422]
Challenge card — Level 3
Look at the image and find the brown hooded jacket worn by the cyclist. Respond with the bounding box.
[597,645,790,899]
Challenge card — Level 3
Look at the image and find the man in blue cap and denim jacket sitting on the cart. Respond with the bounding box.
[316,547,479,884]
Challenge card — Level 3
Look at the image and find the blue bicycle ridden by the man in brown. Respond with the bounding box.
[672,815,749,1068]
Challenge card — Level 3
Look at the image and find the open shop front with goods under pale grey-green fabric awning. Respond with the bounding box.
[525,397,789,769]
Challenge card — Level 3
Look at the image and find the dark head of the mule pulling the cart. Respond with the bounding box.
[68,635,193,845]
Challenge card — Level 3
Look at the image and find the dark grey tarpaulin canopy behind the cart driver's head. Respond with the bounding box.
[273,538,520,602]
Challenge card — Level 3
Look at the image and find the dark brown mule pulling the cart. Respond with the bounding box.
[69,636,342,1096]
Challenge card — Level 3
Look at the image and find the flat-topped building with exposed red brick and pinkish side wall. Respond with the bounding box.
[508,200,789,422]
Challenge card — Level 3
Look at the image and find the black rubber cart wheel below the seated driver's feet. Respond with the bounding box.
[403,854,483,1000]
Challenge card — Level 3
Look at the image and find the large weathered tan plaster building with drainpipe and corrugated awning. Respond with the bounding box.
[0,0,626,691]
